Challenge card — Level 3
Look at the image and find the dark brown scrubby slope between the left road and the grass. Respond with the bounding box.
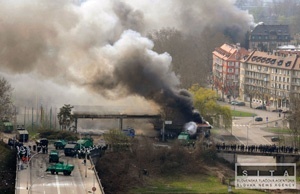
[96,138,234,194]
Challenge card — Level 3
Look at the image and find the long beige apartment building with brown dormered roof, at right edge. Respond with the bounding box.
[239,51,300,109]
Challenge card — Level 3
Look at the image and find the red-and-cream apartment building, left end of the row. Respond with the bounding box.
[212,44,250,99]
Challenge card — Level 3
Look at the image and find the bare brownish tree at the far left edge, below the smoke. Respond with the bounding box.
[0,78,15,121]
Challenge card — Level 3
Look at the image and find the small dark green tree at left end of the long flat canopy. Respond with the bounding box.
[57,104,74,130]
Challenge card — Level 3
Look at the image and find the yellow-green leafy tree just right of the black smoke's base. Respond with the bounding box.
[189,85,232,129]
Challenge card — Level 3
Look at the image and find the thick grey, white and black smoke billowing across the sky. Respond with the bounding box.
[0,0,252,115]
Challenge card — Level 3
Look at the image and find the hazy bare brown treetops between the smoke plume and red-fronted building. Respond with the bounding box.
[148,28,226,88]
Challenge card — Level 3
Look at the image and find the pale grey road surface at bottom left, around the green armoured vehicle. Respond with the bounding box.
[16,146,101,194]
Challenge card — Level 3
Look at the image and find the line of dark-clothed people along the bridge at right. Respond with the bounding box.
[216,143,298,154]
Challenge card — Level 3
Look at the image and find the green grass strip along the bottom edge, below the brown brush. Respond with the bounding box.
[129,175,264,194]
